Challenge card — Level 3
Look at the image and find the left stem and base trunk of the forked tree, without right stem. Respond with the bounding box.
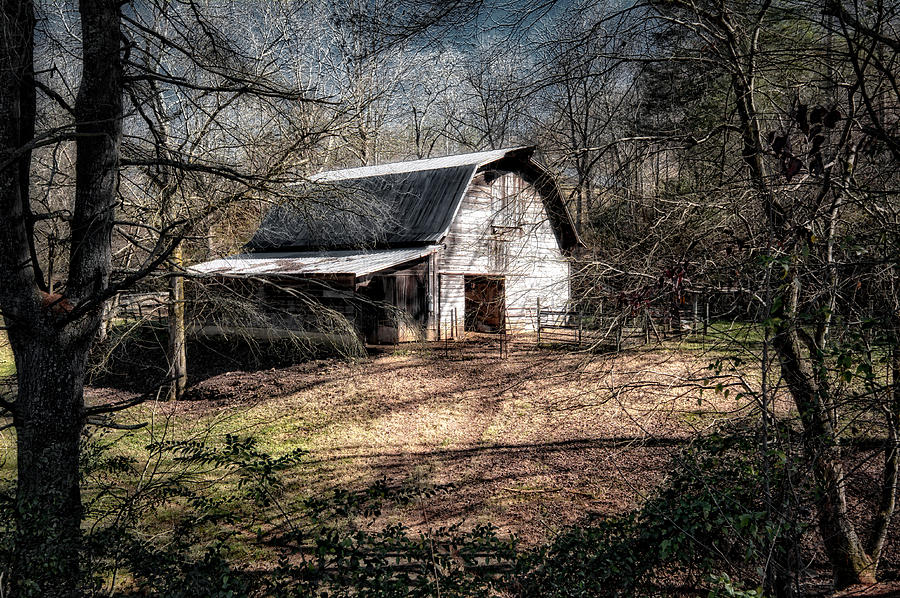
[0,1,90,597]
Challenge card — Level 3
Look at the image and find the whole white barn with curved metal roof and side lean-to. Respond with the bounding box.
[192,147,580,343]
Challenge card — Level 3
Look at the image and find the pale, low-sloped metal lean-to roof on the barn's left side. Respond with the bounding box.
[188,246,439,277]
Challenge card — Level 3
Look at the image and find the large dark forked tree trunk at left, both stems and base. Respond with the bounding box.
[0,0,123,598]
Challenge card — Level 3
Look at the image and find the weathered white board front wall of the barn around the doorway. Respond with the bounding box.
[440,172,569,330]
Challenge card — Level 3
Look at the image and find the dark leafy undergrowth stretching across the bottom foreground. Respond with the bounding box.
[0,428,805,598]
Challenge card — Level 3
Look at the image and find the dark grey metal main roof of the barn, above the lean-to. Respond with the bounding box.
[247,147,533,251]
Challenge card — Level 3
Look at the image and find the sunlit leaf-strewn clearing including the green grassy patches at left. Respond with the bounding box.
[0,326,884,588]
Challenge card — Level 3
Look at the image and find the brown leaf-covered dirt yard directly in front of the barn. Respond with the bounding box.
[91,341,772,545]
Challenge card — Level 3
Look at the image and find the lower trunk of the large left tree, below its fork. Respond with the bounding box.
[10,323,87,597]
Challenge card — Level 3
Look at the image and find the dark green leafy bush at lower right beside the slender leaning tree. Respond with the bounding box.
[523,426,806,598]
